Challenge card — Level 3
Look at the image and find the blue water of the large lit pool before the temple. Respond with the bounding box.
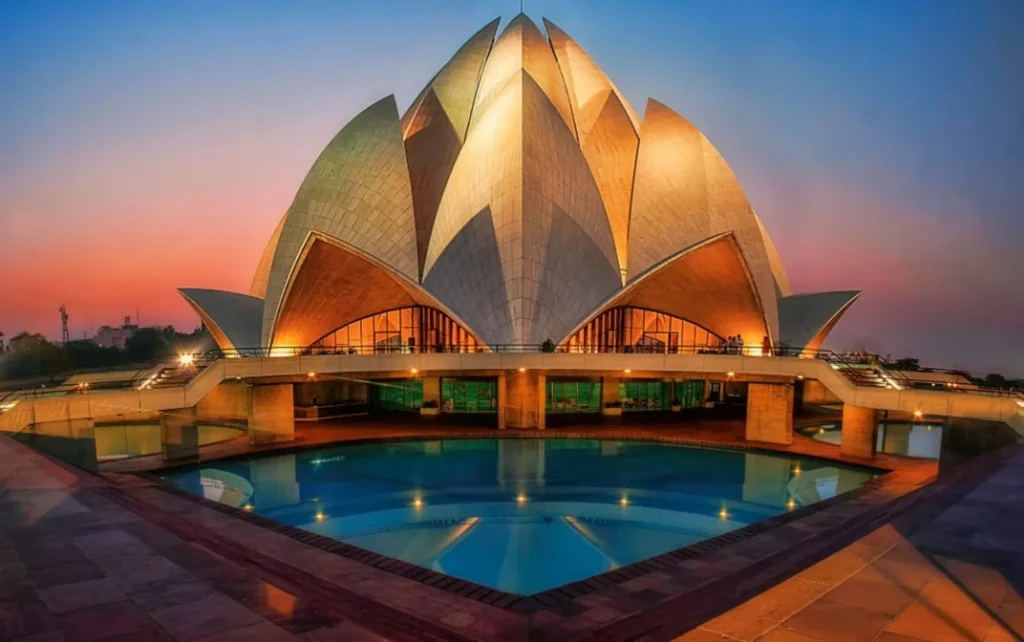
[161,439,876,595]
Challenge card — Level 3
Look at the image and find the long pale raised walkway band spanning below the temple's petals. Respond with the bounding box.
[0,352,1024,434]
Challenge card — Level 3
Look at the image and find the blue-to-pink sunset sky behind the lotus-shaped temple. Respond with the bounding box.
[0,0,1024,376]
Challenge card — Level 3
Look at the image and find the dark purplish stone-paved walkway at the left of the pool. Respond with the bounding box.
[0,437,382,642]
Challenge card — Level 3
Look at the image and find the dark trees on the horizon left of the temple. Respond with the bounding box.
[0,326,214,381]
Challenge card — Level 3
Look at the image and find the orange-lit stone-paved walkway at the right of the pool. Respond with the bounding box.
[678,446,1024,642]
